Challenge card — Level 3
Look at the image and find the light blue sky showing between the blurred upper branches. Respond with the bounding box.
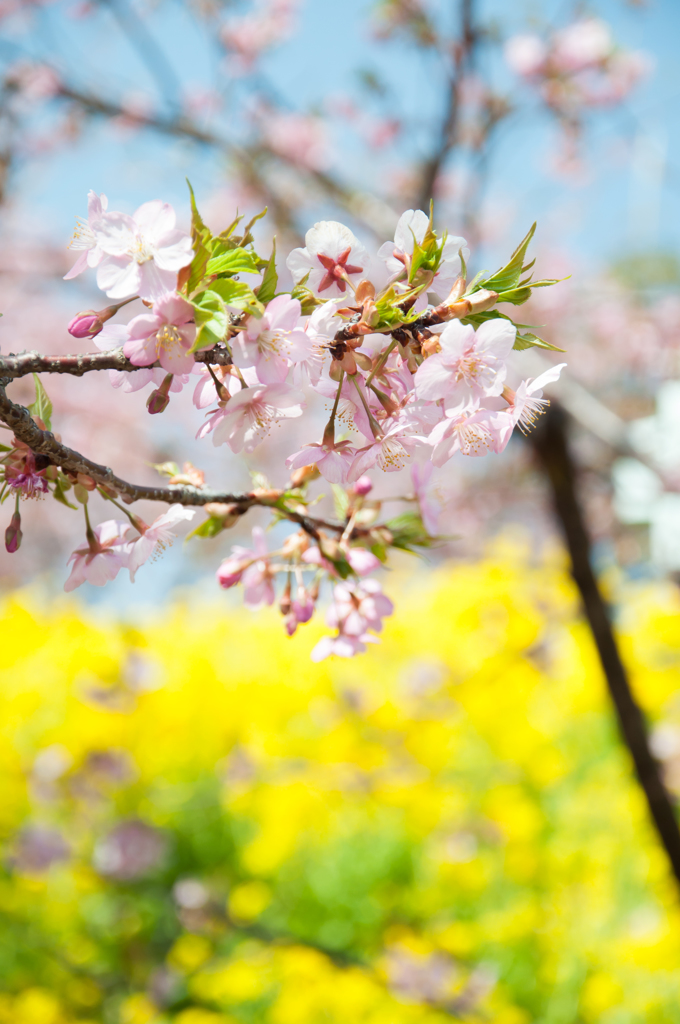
[0,0,680,266]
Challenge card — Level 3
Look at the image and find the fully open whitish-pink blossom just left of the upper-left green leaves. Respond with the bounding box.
[95,200,194,300]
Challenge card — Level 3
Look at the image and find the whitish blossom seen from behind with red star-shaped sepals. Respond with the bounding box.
[286,220,370,298]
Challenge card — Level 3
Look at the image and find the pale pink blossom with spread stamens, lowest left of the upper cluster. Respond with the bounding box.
[198,384,305,453]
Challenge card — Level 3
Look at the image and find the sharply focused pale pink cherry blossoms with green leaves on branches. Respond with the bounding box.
[2,193,564,659]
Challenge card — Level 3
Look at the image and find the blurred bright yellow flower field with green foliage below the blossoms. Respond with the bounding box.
[0,540,680,1024]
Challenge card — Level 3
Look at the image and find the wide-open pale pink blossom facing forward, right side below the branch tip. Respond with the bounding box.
[416,317,517,404]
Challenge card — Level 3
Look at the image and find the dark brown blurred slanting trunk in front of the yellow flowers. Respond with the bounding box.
[530,406,680,883]
